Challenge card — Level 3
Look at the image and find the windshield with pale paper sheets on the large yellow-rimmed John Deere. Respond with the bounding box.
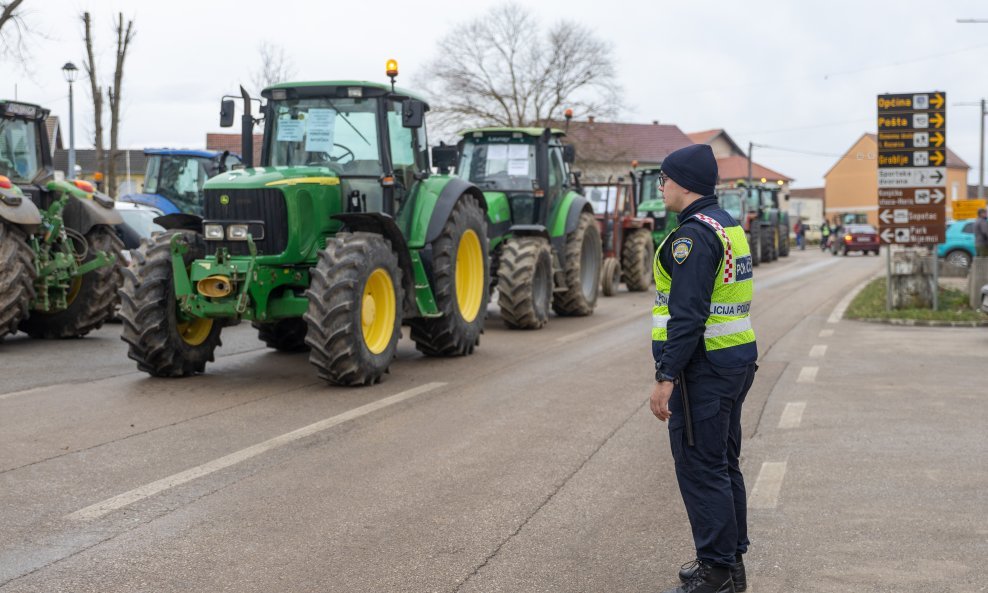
[266,97,382,177]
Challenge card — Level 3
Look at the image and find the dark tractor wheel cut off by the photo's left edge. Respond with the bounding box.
[0,220,36,340]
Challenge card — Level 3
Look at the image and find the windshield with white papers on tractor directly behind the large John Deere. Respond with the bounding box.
[456,136,536,192]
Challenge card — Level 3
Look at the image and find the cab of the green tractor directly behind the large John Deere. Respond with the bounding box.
[456,128,575,225]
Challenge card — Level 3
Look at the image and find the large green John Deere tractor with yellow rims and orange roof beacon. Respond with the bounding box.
[121,69,489,385]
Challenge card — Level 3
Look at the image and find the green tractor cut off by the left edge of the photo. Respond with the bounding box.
[0,101,123,339]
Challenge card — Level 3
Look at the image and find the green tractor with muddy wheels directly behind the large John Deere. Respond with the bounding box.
[433,128,602,329]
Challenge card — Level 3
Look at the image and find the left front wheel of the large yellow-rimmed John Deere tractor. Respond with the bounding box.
[120,231,223,377]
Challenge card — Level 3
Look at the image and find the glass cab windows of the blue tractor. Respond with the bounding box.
[144,154,216,216]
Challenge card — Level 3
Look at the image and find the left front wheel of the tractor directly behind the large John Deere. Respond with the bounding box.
[497,236,552,329]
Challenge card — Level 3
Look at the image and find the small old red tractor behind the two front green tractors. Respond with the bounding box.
[584,177,654,296]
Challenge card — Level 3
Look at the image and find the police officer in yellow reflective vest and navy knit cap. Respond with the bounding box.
[650,144,758,593]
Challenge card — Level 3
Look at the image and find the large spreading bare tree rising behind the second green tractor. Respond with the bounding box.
[421,3,621,134]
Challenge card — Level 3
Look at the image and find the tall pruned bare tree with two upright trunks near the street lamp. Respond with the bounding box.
[82,12,136,191]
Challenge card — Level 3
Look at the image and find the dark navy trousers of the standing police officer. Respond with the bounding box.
[669,358,758,566]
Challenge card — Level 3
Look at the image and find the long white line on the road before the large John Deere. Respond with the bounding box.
[71,383,446,521]
